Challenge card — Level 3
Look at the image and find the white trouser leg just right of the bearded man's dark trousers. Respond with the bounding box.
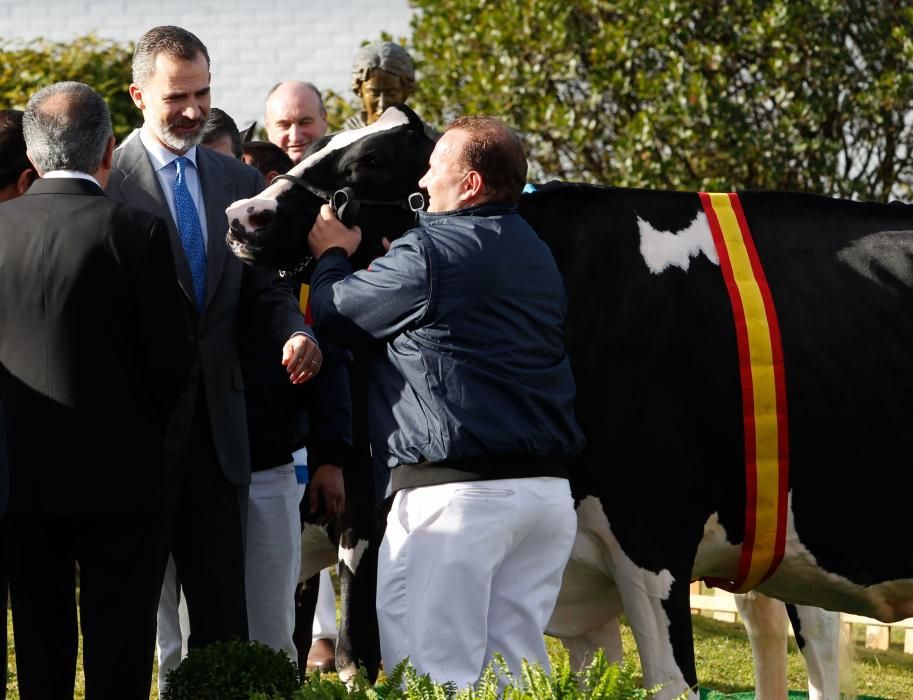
[244,464,302,663]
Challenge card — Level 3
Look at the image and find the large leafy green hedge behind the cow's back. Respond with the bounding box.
[410,0,913,200]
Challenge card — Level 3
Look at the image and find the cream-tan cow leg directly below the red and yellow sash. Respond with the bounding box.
[735,591,787,700]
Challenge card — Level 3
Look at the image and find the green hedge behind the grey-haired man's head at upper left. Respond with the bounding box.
[0,35,136,141]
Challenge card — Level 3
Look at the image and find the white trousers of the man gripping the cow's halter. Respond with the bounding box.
[377,477,577,688]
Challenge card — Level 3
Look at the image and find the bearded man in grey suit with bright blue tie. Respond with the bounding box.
[108,26,321,647]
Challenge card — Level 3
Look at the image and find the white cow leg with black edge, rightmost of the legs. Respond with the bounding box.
[786,605,840,700]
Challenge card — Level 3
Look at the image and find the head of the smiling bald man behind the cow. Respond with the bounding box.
[266,80,327,164]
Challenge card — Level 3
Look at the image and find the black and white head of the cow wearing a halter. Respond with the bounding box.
[226,105,434,270]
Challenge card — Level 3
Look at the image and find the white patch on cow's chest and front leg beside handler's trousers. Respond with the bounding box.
[547,496,698,698]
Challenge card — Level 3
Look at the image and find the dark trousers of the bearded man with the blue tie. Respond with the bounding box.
[162,391,248,648]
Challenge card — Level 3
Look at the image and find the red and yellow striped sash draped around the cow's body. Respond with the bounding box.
[700,192,789,593]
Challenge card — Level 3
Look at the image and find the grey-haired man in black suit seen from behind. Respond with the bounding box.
[0,82,192,700]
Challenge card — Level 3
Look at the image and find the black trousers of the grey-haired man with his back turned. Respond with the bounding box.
[5,512,163,700]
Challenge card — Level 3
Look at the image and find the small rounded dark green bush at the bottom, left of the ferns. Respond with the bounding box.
[162,641,298,700]
